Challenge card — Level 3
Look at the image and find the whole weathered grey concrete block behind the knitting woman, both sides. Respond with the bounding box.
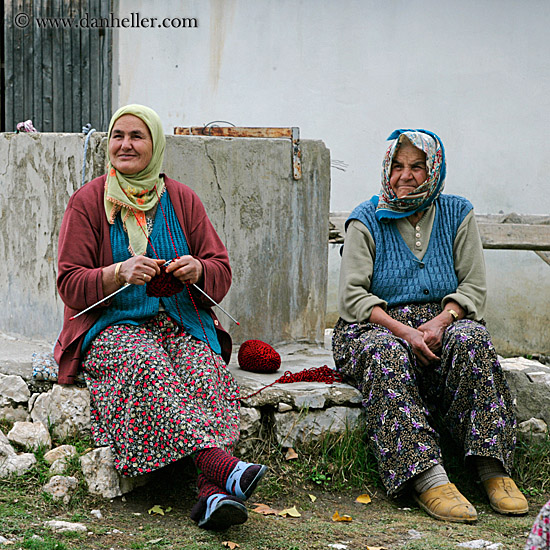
[0,133,330,350]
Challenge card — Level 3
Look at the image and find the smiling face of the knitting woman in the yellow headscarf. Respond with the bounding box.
[109,115,153,174]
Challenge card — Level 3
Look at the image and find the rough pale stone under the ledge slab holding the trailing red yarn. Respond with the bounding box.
[274,407,361,447]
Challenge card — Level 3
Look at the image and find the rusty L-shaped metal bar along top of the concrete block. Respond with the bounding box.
[174,126,302,180]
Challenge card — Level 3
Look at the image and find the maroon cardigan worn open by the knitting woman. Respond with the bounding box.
[54,176,235,384]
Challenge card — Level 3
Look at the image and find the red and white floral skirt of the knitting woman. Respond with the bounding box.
[82,313,240,476]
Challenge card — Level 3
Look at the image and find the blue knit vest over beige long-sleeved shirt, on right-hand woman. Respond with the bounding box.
[346,195,473,307]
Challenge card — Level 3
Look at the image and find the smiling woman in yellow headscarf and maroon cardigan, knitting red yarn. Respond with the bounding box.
[55,105,266,530]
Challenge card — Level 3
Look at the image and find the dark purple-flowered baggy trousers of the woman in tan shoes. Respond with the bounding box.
[332,304,516,494]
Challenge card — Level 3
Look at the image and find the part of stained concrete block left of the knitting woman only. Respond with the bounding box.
[0,133,105,341]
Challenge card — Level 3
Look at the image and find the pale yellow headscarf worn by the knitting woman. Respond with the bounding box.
[104,105,166,255]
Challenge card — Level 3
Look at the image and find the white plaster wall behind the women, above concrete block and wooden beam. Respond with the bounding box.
[115,0,550,214]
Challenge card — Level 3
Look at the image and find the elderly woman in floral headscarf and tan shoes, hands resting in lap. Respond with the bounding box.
[333,130,528,522]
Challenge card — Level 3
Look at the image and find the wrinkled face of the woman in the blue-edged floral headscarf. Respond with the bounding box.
[390,141,428,199]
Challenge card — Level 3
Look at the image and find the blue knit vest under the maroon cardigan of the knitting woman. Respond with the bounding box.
[82,192,221,354]
